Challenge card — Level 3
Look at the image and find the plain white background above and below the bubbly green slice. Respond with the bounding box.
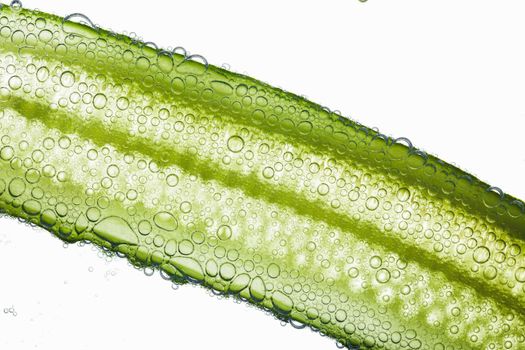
[0,0,525,350]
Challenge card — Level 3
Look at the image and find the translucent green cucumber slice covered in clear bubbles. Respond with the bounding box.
[0,6,525,349]
